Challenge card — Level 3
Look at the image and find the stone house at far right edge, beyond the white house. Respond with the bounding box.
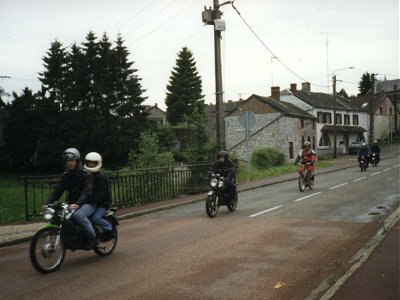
[350,90,399,142]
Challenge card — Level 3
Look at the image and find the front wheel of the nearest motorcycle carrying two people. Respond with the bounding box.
[29,227,65,274]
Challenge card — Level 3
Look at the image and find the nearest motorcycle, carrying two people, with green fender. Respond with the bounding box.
[29,203,119,274]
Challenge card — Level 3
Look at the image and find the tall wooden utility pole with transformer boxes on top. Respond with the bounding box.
[202,0,232,150]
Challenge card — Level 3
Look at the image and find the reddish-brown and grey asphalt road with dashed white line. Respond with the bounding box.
[0,157,400,299]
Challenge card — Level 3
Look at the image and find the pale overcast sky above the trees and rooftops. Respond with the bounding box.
[0,0,399,109]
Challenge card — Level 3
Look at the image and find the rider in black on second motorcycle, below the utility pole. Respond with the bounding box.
[210,150,236,195]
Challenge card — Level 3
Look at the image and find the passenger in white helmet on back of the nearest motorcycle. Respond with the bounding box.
[84,152,114,241]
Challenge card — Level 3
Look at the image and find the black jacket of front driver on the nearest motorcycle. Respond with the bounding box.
[47,165,93,206]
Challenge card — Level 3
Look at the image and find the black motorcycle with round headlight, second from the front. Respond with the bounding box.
[206,173,238,218]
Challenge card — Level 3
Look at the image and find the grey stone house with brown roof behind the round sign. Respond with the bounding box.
[225,87,316,161]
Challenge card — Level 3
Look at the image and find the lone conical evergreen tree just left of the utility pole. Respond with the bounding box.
[165,47,204,125]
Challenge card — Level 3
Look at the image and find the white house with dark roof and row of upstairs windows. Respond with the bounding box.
[280,82,369,154]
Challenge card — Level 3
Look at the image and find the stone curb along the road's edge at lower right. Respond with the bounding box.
[319,208,400,300]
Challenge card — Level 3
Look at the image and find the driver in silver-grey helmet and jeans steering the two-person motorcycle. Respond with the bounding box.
[46,148,96,250]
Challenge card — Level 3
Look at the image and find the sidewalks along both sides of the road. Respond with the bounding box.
[0,146,400,300]
